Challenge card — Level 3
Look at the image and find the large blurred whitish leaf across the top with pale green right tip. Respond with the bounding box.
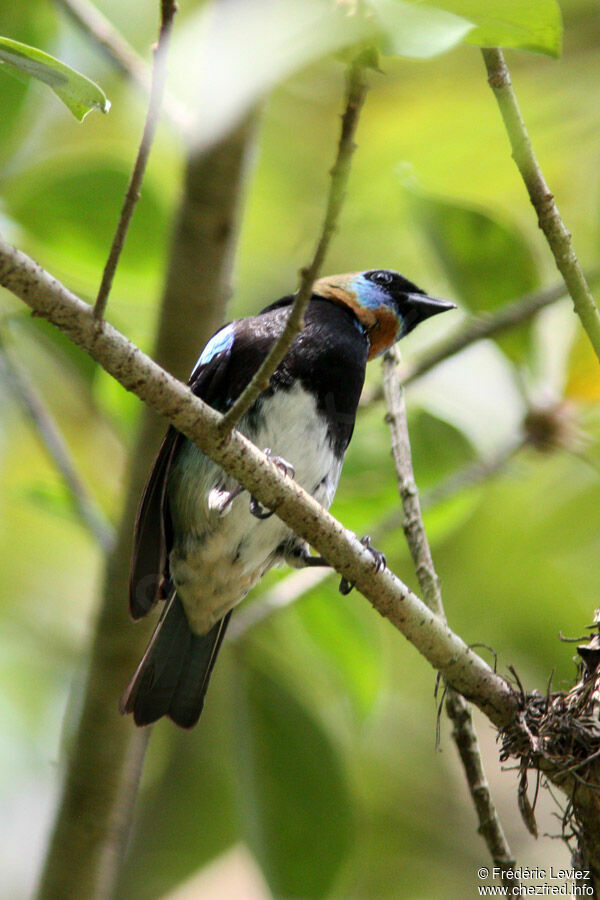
[170,0,473,153]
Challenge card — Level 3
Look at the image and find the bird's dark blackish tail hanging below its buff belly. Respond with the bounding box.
[119,593,231,728]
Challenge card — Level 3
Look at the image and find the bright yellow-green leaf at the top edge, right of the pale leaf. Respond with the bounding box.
[426,0,562,56]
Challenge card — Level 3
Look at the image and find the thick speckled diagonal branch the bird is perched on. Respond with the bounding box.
[0,238,518,727]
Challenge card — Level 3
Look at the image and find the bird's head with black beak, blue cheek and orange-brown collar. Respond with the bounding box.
[313,269,456,359]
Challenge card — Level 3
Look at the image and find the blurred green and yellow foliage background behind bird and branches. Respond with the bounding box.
[0,0,600,900]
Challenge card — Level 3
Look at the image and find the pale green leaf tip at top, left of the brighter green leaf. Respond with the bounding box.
[371,0,473,59]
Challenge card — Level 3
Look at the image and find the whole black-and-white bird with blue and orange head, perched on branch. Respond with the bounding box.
[120,269,455,728]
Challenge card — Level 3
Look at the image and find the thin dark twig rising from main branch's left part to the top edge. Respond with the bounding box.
[94,0,177,320]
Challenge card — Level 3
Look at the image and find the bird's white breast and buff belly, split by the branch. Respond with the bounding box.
[169,382,342,633]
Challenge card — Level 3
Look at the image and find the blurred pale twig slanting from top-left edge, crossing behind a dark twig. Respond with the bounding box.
[54,0,189,132]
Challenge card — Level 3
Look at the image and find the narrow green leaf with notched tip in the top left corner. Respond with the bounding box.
[0,37,110,122]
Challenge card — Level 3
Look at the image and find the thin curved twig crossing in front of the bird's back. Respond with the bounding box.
[221,57,368,436]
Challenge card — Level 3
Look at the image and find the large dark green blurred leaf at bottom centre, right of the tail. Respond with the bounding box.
[236,665,351,900]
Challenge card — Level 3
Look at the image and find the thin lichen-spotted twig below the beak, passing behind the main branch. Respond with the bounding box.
[383,348,515,886]
